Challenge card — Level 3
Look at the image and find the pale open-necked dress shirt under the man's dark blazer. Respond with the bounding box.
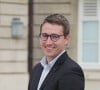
[37,50,65,90]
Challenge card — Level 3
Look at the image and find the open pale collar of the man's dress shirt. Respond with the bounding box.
[40,50,65,68]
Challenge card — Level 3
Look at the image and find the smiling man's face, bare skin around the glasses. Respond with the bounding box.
[40,23,69,61]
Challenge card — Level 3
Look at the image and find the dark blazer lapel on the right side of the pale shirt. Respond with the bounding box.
[40,52,66,90]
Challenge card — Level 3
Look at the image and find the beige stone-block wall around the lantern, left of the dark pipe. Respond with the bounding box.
[0,0,28,90]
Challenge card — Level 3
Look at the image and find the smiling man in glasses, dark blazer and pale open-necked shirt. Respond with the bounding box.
[28,14,84,90]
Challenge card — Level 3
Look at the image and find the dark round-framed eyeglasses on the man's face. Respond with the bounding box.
[40,33,64,42]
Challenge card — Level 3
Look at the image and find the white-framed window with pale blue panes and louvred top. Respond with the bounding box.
[78,0,100,69]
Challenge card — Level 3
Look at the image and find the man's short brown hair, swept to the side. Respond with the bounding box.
[40,14,70,36]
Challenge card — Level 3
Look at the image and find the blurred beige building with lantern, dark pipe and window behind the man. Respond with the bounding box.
[0,0,100,90]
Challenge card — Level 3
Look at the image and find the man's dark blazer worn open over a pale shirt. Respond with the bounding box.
[28,52,84,90]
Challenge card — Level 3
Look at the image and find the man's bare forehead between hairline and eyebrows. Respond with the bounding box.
[42,23,63,33]
